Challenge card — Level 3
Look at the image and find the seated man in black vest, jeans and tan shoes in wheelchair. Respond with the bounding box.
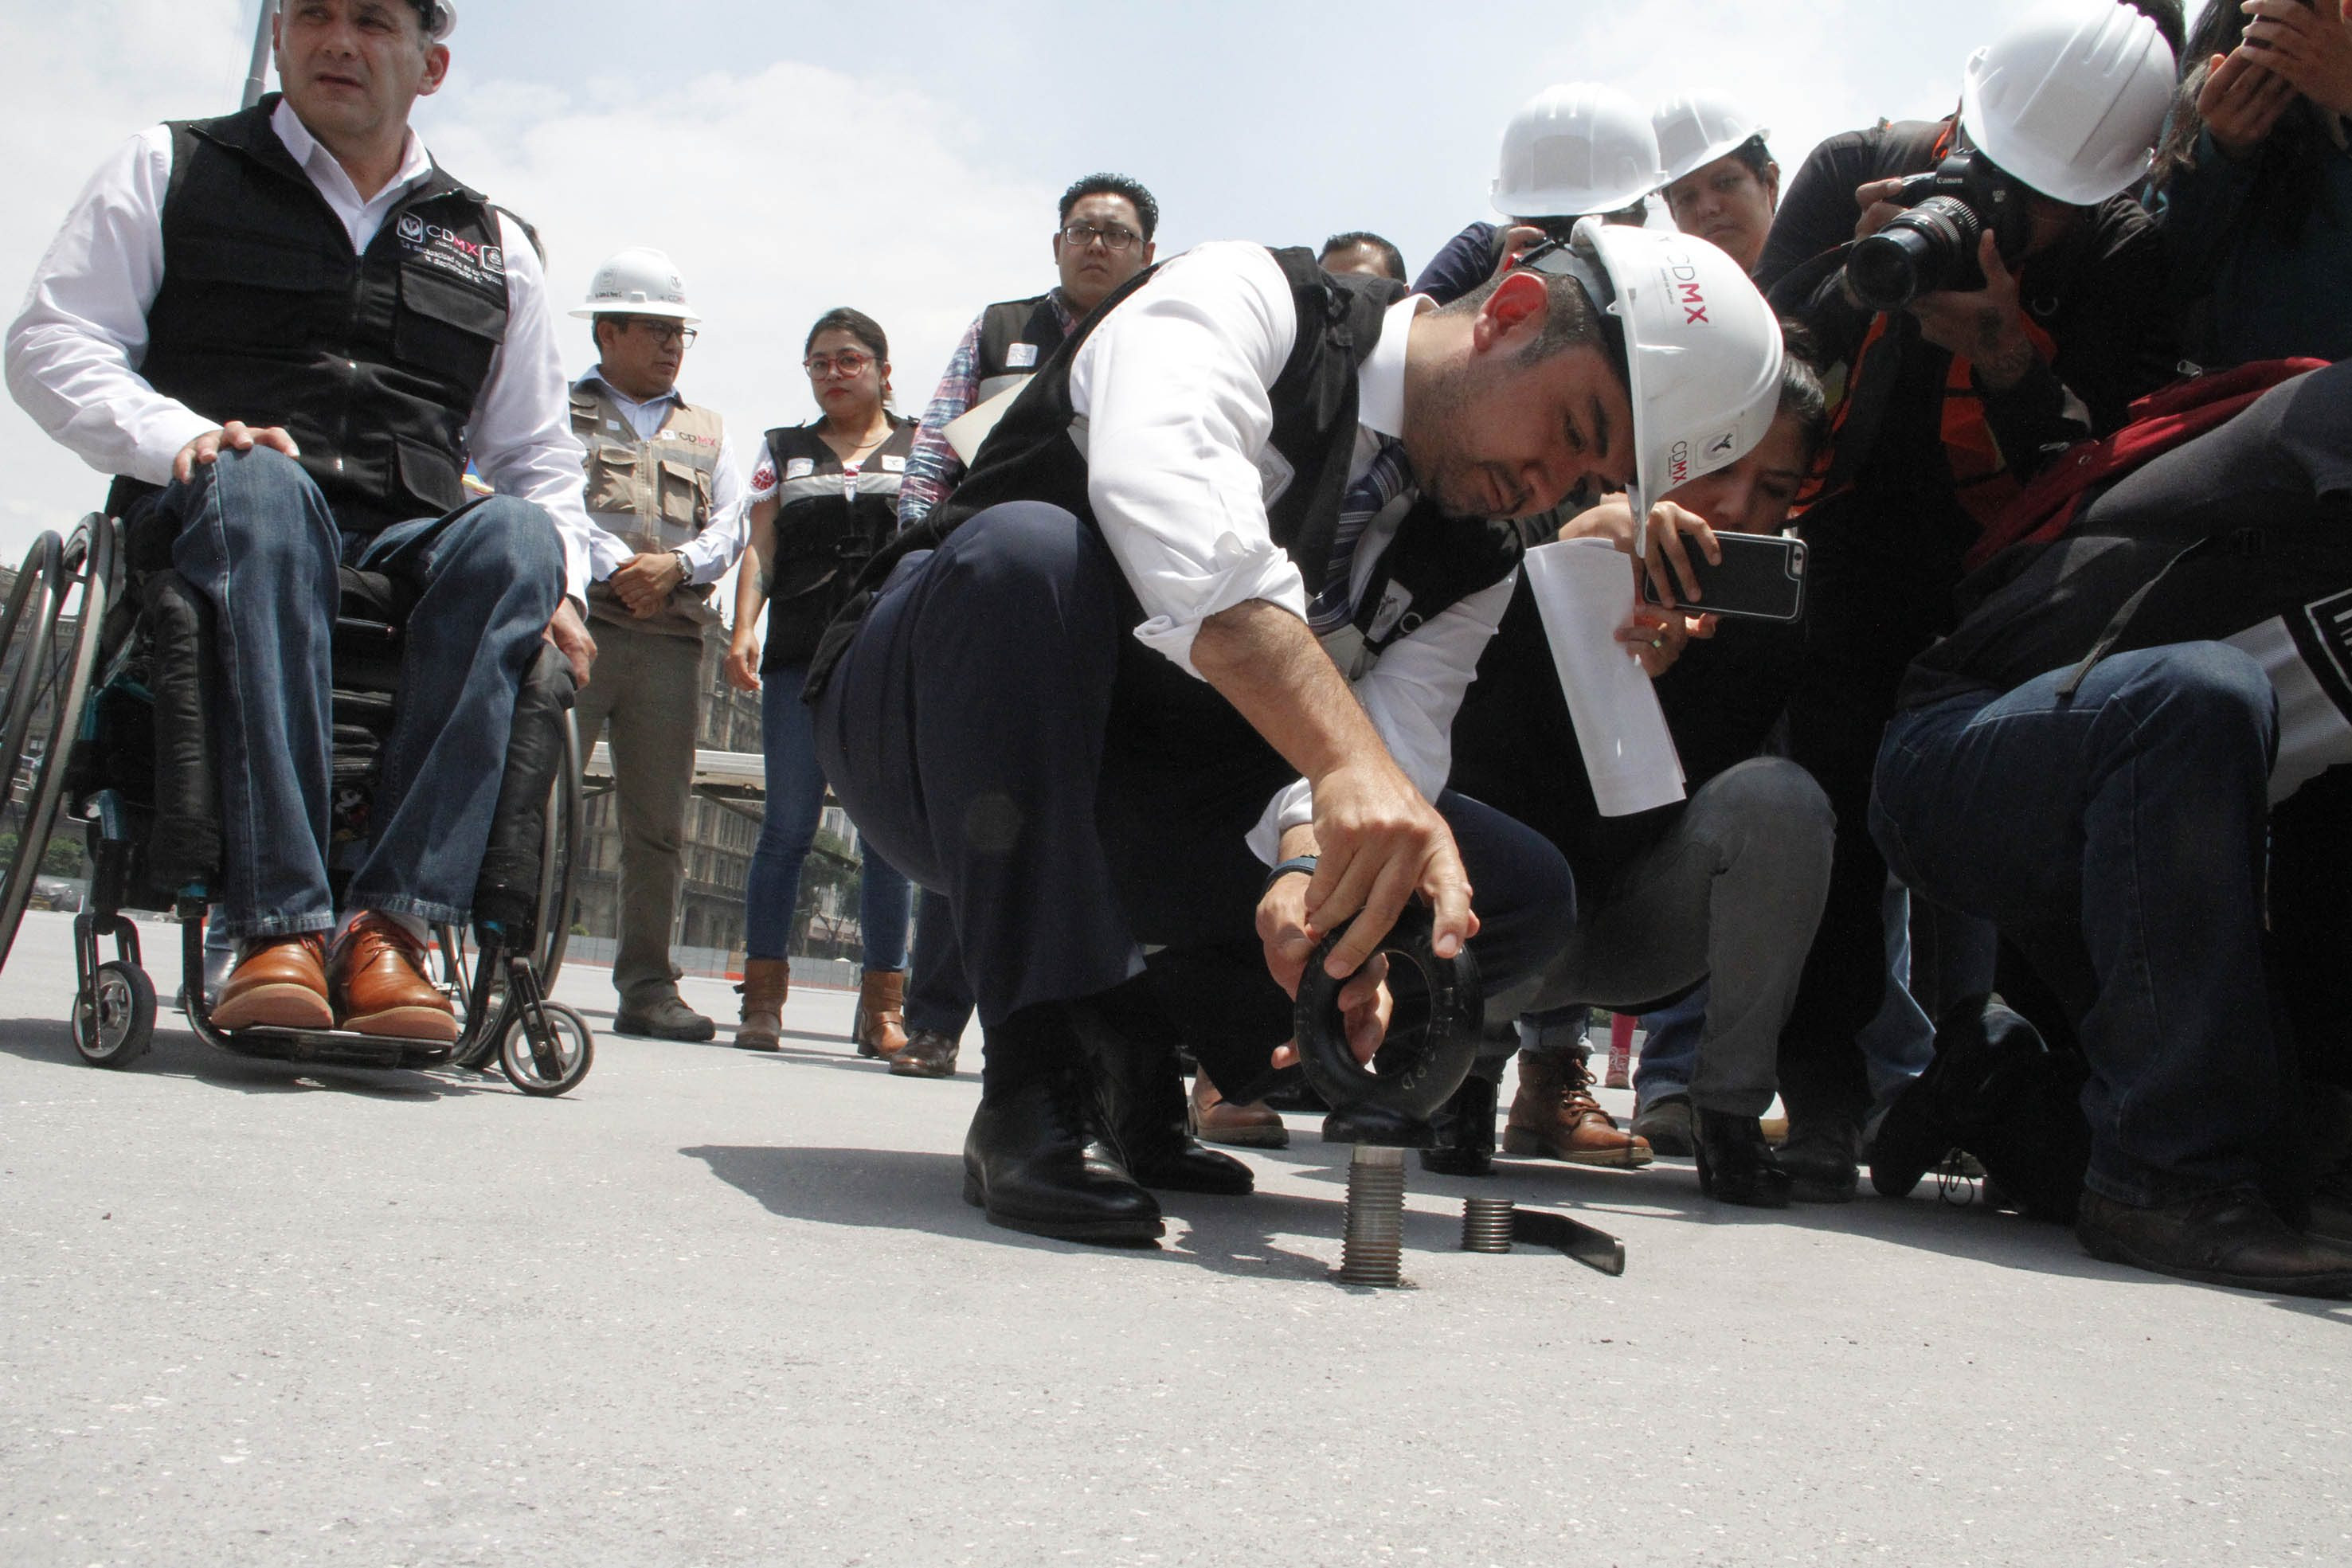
[7,0,595,1042]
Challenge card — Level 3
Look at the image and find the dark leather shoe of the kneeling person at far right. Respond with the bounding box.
[2075,1190,2352,1300]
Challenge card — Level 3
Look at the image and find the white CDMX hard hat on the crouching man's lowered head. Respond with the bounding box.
[1536,219,1785,517]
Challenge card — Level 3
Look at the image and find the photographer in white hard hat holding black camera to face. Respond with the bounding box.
[1757,0,2174,1192]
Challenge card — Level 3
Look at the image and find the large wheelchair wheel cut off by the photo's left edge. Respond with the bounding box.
[0,514,115,964]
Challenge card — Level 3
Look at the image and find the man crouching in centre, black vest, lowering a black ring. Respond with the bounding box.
[812,223,1752,1244]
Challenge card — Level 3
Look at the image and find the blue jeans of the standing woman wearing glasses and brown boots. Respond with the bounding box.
[743,667,915,968]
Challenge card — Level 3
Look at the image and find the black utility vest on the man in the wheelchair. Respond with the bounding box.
[113,94,506,534]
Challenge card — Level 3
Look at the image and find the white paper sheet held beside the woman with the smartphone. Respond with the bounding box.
[1526,538,1681,815]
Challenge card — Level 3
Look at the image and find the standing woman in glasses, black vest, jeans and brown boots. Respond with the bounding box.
[726,311,918,1060]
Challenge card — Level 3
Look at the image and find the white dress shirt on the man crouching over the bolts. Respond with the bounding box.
[1070,242,1517,865]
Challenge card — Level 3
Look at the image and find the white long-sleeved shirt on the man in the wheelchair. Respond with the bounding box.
[7,99,597,604]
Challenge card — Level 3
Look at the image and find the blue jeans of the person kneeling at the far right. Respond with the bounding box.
[1870,642,2286,1203]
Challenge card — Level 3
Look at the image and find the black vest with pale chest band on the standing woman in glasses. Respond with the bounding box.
[760,414,922,670]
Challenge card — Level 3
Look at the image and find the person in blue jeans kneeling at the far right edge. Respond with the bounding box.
[1870,365,2352,1298]
